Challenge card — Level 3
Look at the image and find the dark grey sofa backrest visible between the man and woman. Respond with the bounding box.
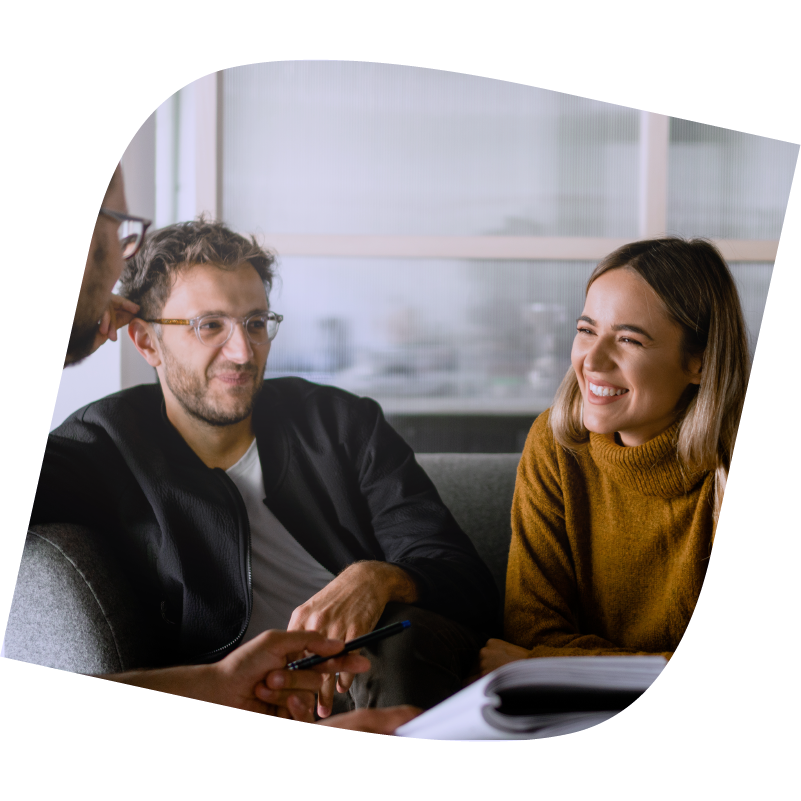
[417,453,520,599]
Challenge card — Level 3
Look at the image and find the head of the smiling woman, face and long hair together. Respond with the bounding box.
[551,238,748,522]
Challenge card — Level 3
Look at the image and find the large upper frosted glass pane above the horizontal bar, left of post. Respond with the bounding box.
[223,61,639,237]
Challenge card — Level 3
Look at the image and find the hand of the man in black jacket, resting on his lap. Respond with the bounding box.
[287,562,417,718]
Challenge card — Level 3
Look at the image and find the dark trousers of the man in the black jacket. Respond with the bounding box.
[334,603,487,712]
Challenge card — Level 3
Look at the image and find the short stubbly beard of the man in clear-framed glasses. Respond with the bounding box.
[162,348,264,427]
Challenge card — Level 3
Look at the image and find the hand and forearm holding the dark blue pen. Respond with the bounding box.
[100,631,370,723]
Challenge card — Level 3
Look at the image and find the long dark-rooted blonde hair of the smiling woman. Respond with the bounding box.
[550,237,749,524]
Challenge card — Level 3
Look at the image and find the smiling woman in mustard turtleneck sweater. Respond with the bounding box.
[481,238,748,674]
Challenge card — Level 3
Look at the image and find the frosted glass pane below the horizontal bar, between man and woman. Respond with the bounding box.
[267,257,772,414]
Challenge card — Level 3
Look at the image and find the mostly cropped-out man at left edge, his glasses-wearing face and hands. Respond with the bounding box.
[36,165,420,734]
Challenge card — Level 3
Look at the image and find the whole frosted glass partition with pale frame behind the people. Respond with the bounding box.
[53,61,799,452]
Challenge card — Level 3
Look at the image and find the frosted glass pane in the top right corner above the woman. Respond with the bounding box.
[668,119,798,239]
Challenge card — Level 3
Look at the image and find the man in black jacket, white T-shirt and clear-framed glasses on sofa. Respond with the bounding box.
[32,206,499,717]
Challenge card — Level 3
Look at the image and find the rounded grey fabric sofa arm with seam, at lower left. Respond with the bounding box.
[5,524,153,673]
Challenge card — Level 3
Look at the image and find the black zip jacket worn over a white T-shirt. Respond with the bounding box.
[31,378,500,663]
